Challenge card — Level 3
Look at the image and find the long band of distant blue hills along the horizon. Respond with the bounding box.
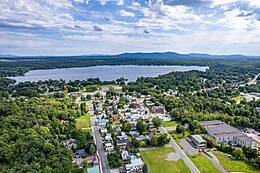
[0,52,260,59]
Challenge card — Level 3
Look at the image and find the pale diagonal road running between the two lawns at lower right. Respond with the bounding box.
[160,127,200,173]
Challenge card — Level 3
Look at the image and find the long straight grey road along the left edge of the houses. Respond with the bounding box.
[88,102,111,173]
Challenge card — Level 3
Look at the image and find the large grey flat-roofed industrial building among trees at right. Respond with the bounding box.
[200,120,256,148]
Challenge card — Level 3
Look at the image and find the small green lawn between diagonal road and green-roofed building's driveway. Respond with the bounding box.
[188,154,221,173]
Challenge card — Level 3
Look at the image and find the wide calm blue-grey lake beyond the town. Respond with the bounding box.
[13,65,208,82]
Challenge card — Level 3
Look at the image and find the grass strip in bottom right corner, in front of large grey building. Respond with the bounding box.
[212,151,260,173]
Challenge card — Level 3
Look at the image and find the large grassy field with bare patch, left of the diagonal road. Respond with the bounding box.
[140,148,190,173]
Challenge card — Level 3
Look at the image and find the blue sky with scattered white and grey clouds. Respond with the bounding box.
[0,0,260,56]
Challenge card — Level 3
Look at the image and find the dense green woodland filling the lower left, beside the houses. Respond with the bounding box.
[0,98,92,173]
